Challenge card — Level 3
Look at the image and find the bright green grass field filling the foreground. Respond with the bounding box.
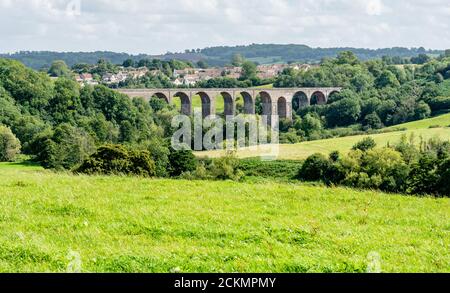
[0,164,450,272]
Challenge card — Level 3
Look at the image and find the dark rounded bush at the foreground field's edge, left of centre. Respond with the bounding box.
[76,145,156,177]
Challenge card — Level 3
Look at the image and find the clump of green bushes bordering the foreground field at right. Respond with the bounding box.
[298,138,450,196]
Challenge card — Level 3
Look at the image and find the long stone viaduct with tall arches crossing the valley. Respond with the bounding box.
[117,87,341,119]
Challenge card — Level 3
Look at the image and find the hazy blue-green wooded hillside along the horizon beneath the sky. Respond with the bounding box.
[0,44,443,69]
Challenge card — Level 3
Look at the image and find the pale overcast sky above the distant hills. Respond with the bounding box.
[0,0,450,54]
